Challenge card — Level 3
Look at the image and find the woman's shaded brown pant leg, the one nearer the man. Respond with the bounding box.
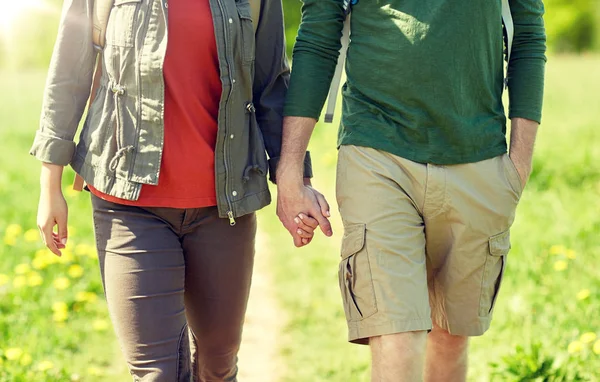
[183,208,258,382]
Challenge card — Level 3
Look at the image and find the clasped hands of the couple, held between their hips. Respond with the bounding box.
[277,182,333,247]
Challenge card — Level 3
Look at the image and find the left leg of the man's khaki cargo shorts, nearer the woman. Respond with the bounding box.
[336,146,431,344]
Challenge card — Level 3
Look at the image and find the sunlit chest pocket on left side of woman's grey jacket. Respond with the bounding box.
[106,0,142,47]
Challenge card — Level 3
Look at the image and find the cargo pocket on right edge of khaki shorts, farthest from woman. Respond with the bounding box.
[479,230,510,317]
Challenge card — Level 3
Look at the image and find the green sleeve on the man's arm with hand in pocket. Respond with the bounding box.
[508,0,546,122]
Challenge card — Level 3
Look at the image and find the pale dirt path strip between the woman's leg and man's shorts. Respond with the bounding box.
[238,228,284,382]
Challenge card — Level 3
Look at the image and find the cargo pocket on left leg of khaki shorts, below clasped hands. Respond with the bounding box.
[339,224,377,322]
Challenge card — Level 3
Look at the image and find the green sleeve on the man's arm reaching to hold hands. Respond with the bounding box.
[284,0,345,119]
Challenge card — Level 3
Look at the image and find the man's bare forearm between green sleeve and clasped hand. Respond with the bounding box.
[277,117,317,186]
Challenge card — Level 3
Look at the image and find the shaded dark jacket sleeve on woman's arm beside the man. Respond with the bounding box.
[253,0,312,182]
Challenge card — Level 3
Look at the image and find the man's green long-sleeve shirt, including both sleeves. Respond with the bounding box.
[285,0,546,164]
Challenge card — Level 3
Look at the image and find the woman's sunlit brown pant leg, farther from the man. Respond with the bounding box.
[92,196,190,382]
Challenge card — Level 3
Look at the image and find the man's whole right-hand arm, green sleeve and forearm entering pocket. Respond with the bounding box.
[508,0,546,186]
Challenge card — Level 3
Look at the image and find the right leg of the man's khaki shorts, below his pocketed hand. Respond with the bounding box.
[425,155,522,336]
